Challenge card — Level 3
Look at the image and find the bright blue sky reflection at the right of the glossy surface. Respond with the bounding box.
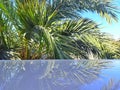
[80,60,120,90]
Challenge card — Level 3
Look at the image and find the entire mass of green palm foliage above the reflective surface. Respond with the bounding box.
[0,0,120,60]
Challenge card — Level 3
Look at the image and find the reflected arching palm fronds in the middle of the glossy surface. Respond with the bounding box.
[39,61,109,85]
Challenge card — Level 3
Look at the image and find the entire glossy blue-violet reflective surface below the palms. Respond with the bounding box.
[0,60,120,90]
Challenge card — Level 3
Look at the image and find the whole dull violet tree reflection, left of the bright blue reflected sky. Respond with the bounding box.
[0,60,111,90]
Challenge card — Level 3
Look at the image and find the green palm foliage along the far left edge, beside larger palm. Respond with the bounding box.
[0,0,18,59]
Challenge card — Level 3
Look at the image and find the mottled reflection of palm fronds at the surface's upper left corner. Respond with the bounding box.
[0,61,24,80]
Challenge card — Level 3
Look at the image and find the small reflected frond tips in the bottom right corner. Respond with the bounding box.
[102,79,120,90]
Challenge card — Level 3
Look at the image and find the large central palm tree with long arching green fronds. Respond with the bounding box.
[1,0,117,59]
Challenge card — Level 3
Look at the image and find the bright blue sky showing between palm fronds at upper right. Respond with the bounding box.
[83,0,120,39]
